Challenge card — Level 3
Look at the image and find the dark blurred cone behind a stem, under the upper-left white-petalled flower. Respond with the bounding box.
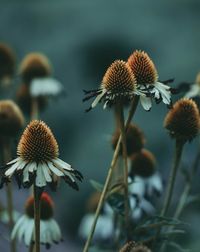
[16,84,48,114]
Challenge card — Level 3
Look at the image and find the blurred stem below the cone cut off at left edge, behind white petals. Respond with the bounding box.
[3,140,16,252]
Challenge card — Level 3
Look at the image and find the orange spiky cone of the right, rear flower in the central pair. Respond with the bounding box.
[128,50,158,84]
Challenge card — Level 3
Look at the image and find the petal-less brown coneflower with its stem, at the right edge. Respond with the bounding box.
[161,98,200,215]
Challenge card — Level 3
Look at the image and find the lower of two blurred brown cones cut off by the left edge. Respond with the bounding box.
[0,100,25,138]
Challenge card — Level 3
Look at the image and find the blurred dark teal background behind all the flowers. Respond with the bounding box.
[0,0,200,252]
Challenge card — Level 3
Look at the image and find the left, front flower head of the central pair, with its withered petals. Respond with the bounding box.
[83,60,136,111]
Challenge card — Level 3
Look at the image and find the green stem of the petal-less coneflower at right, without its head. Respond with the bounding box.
[161,141,184,216]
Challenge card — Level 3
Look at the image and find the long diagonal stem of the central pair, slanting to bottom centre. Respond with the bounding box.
[83,96,139,252]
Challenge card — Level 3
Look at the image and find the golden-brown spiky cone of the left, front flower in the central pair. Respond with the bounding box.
[102,60,136,94]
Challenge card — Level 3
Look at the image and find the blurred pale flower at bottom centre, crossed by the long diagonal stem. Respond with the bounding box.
[79,192,114,242]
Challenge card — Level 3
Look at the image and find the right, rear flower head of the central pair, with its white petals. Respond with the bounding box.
[128,50,173,111]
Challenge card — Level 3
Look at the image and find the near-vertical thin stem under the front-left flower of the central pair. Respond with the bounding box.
[115,103,130,240]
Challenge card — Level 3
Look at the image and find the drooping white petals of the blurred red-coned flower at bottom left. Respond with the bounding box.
[11,214,62,247]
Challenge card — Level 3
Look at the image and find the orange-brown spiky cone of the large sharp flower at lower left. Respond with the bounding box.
[17,120,59,163]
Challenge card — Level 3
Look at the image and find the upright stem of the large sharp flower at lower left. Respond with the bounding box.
[33,185,40,252]
